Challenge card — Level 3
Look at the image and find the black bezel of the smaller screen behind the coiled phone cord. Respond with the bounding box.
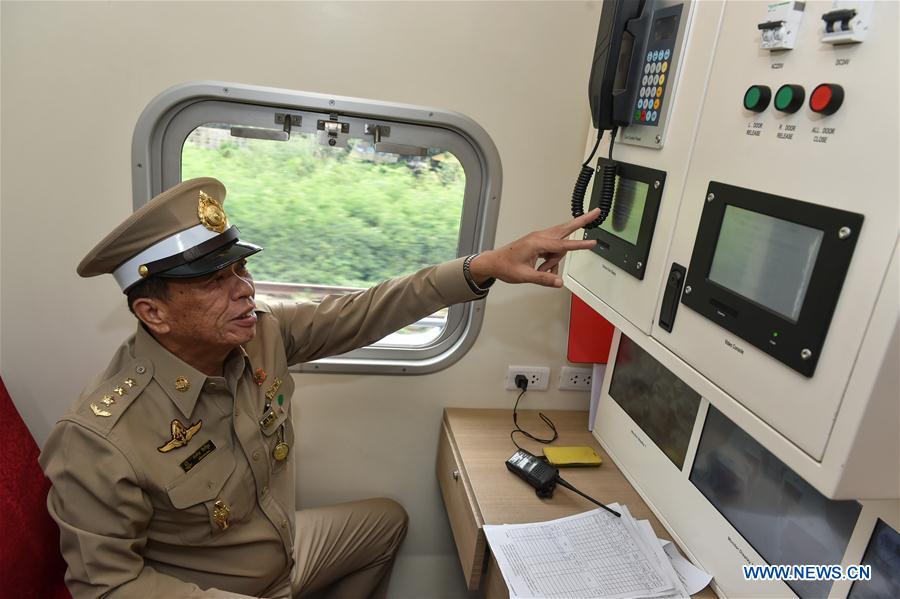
[584,158,666,280]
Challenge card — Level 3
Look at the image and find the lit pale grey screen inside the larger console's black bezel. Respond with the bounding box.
[709,205,824,322]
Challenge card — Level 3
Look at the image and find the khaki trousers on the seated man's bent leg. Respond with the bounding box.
[291,499,409,599]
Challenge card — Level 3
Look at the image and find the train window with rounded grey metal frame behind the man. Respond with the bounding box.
[135,86,499,373]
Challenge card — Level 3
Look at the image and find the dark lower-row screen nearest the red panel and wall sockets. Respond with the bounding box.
[609,335,700,470]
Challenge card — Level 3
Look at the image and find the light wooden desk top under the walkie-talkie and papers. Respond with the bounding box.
[444,408,716,599]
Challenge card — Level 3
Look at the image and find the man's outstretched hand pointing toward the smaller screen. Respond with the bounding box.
[469,208,600,287]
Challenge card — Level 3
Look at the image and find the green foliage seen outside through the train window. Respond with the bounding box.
[182,127,465,287]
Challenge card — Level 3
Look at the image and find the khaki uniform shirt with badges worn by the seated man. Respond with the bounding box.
[40,259,480,598]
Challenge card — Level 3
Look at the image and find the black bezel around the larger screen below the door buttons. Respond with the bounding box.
[681,181,864,377]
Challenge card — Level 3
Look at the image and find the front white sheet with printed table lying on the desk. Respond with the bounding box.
[484,504,687,599]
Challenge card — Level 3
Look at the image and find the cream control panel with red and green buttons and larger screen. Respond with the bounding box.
[651,2,900,478]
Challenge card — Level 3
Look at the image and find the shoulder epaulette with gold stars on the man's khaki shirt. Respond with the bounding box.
[63,359,153,436]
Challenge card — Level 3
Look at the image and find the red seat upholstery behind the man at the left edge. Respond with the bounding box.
[0,379,72,599]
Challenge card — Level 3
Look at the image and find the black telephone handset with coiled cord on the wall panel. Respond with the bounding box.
[572,0,681,229]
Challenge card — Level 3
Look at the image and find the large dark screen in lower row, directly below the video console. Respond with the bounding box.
[690,406,862,598]
